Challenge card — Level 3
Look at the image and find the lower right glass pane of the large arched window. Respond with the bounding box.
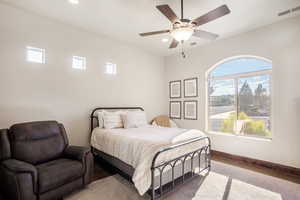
[237,74,271,137]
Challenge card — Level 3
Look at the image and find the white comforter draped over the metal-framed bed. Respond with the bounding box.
[91,126,207,195]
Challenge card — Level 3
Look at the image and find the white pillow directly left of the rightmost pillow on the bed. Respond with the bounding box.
[103,111,124,129]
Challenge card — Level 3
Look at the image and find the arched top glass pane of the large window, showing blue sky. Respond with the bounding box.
[210,58,272,78]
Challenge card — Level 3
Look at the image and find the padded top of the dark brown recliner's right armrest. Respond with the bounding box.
[64,146,91,161]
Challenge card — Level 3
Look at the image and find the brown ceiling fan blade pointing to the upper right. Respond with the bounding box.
[193,5,231,26]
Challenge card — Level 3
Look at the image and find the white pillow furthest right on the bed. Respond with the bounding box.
[122,111,148,128]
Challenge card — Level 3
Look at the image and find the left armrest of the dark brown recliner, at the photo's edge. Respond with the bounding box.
[0,159,38,200]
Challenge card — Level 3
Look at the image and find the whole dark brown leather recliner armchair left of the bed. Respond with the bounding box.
[0,121,94,200]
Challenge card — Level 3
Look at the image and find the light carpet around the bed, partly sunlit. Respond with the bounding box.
[66,161,300,200]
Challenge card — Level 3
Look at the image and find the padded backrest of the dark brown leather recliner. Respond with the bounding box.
[9,121,68,165]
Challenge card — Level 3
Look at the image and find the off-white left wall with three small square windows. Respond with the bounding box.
[0,4,167,145]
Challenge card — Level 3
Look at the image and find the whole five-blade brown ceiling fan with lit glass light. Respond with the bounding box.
[140,0,230,49]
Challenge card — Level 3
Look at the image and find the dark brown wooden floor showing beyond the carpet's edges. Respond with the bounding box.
[94,155,300,184]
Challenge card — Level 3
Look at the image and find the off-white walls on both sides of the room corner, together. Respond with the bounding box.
[0,4,300,167]
